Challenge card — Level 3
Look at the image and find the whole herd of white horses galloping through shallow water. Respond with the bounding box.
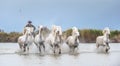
[18,25,110,54]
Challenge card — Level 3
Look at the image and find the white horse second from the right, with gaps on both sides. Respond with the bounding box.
[66,27,79,53]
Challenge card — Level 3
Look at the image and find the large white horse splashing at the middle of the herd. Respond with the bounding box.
[46,25,62,54]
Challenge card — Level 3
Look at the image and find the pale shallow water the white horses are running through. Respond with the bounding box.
[0,43,120,66]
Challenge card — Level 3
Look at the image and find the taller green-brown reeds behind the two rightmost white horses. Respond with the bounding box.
[63,29,120,43]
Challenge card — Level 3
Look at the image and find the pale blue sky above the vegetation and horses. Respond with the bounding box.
[0,0,120,32]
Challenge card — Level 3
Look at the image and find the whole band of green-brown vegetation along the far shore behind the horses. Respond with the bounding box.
[0,29,120,43]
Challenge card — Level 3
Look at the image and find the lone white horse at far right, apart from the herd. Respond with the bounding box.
[96,27,110,52]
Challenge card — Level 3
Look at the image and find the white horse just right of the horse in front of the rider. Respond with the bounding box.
[34,25,49,53]
